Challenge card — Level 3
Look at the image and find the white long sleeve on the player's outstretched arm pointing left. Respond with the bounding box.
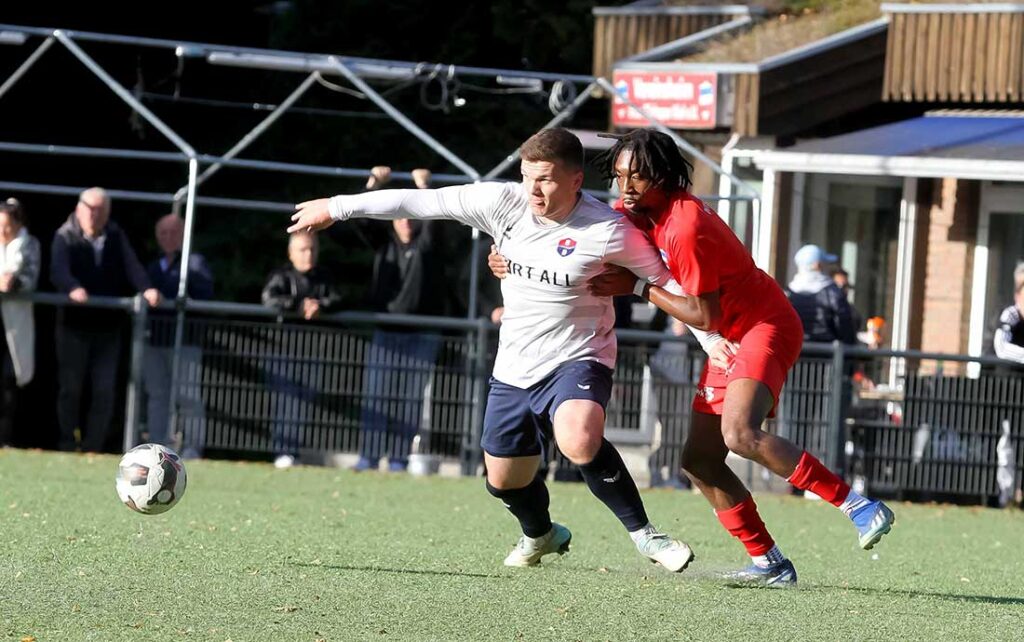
[328,182,521,237]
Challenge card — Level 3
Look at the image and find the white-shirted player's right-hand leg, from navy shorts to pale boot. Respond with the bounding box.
[552,361,693,572]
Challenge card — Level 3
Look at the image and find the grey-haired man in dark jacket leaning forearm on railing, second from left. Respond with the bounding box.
[50,187,160,452]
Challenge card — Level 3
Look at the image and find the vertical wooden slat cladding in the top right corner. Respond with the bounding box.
[882,12,1024,102]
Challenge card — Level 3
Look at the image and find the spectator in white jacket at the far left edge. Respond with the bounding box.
[0,199,39,447]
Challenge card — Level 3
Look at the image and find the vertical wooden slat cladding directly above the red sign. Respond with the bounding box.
[594,12,736,80]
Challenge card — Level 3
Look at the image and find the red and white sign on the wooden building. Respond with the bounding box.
[611,70,718,129]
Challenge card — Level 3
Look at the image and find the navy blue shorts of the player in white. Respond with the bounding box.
[480,361,611,457]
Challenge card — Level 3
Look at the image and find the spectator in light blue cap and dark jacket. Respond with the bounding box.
[786,245,857,344]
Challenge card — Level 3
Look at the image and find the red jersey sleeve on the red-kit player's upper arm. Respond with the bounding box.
[665,203,721,296]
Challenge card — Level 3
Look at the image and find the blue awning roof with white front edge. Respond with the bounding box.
[754,113,1024,181]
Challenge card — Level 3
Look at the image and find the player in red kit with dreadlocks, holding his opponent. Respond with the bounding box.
[591,129,895,587]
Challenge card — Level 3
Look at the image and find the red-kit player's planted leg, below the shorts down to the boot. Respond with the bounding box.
[683,411,797,587]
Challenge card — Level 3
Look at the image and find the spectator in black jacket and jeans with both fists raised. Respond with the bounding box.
[354,167,442,472]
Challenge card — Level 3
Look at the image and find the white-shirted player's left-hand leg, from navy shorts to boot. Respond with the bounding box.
[480,379,572,566]
